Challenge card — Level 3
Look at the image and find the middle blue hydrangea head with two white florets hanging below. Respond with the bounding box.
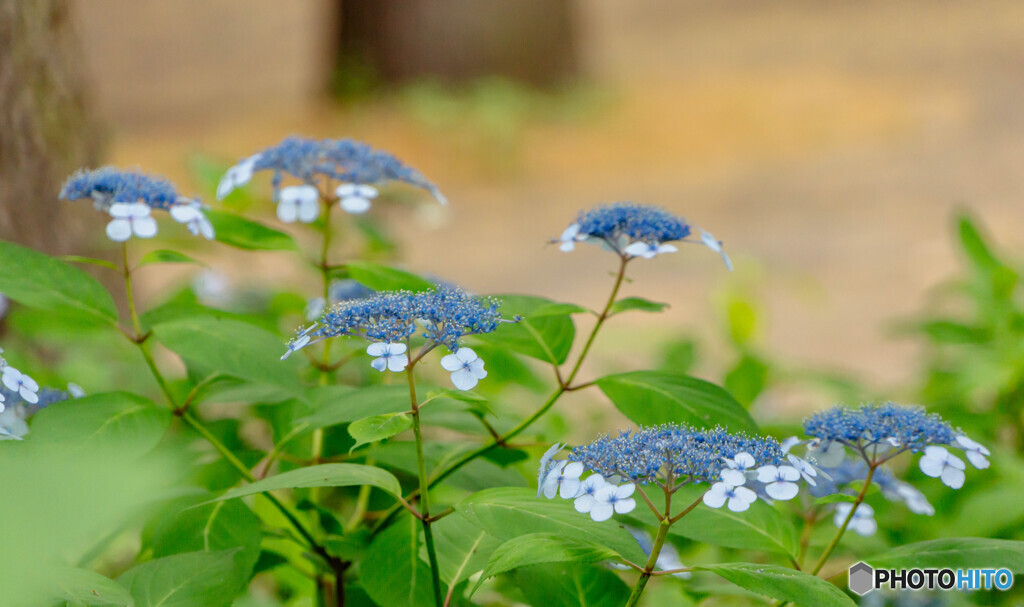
[282,286,506,390]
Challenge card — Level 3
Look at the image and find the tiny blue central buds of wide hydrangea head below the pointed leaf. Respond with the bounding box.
[568,424,782,484]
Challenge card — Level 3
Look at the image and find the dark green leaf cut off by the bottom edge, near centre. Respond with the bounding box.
[513,563,630,607]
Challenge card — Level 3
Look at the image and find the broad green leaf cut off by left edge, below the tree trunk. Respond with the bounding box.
[0,241,118,321]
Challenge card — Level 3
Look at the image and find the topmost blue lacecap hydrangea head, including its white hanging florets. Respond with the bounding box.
[217,137,447,223]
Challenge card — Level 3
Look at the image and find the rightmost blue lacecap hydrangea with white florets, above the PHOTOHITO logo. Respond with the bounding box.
[784,402,990,535]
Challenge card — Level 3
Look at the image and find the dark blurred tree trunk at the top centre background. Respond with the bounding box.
[338,0,579,86]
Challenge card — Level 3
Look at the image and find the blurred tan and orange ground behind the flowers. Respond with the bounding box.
[68,0,1024,403]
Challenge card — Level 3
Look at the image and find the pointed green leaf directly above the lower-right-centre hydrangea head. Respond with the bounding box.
[597,371,757,433]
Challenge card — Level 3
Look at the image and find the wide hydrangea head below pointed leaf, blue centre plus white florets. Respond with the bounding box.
[538,424,801,521]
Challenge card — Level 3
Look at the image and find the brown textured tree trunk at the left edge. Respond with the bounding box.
[0,0,102,254]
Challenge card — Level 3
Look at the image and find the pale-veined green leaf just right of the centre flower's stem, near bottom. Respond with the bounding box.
[428,513,501,586]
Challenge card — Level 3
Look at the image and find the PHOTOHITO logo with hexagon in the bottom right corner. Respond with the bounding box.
[850,561,1014,596]
